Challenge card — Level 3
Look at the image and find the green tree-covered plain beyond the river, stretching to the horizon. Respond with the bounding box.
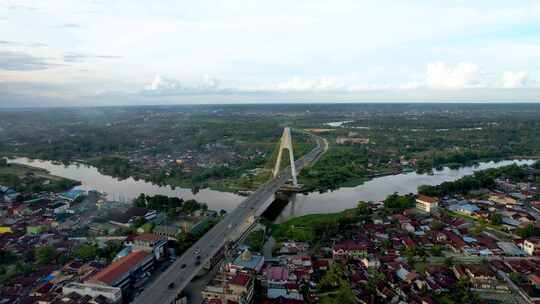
[0,104,540,191]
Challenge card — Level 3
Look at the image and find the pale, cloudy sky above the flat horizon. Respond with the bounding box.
[0,0,540,107]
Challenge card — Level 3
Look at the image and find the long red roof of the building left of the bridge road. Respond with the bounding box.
[90,251,149,285]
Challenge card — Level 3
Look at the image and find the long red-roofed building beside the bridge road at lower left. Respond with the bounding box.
[87,251,154,288]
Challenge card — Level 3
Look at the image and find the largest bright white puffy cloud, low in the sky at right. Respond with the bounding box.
[426,61,482,89]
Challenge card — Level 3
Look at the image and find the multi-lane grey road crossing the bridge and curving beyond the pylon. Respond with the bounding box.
[133,134,328,304]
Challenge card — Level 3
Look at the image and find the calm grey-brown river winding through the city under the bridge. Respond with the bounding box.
[9,158,534,221]
